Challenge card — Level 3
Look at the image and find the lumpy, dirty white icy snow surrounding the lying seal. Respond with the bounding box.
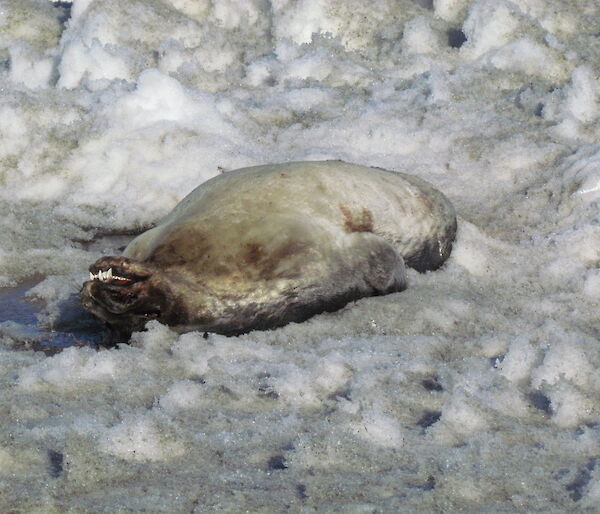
[0,0,600,506]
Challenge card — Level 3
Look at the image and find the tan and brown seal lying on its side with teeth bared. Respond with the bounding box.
[81,161,456,338]
